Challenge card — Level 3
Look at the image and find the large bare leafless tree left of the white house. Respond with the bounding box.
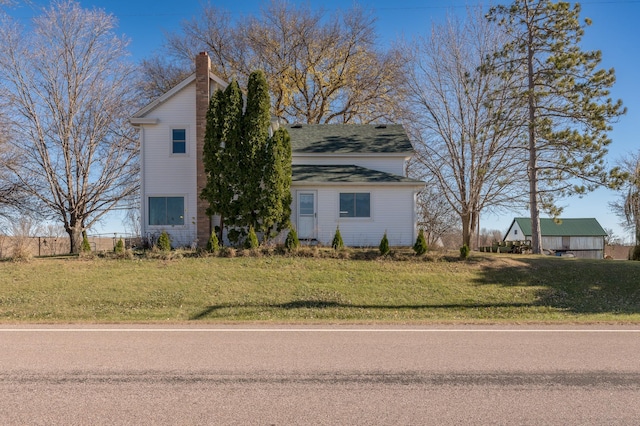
[0,1,138,252]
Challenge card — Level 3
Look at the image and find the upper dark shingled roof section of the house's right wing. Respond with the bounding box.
[285,124,413,154]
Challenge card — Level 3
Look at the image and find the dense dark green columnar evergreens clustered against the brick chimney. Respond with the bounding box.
[201,71,291,243]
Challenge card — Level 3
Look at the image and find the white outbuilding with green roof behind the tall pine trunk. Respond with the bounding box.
[504,217,607,259]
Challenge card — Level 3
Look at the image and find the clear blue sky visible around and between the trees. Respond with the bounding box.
[10,0,640,241]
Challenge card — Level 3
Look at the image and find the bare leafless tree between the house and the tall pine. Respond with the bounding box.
[404,9,526,246]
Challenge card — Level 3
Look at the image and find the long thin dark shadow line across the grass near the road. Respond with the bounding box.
[189,300,533,321]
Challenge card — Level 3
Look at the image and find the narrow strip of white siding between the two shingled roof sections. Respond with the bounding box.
[292,153,406,176]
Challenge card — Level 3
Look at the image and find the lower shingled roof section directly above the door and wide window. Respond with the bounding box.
[292,164,424,185]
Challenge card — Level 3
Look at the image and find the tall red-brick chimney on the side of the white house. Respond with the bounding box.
[196,52,212,247]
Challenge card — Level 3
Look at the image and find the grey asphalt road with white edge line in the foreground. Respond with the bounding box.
[0,326,640,425]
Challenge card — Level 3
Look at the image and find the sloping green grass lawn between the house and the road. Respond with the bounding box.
[0,254,640,323]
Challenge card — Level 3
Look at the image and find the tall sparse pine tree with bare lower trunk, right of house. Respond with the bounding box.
[488,0,625,253]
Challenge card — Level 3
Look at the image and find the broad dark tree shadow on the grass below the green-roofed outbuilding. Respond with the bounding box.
[475,253,640,314]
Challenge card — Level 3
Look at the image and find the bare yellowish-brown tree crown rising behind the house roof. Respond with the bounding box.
[145,1,402,123]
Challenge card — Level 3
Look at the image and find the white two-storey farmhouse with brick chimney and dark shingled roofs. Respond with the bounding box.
[130,53,424,246]
